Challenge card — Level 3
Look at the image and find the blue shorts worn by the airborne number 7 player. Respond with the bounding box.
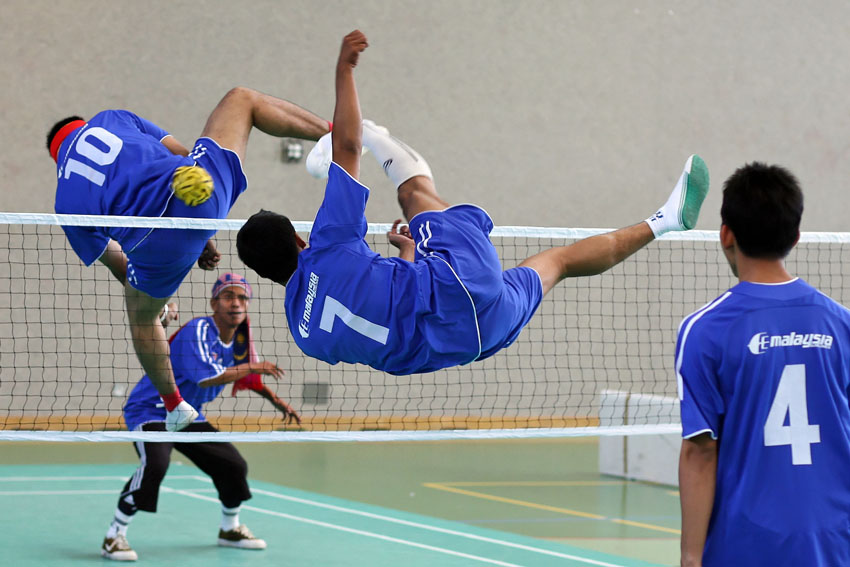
[410,205,543,360]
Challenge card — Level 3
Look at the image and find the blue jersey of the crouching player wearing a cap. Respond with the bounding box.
[124,317,235,430]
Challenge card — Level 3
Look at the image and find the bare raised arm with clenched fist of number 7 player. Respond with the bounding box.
[332,30,369,179]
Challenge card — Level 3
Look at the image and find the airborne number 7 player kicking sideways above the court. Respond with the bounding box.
[237,31,708,375]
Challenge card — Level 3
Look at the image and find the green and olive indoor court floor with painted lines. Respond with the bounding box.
[0,439,679,567]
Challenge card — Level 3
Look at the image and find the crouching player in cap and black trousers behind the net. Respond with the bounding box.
[101,274,301,561]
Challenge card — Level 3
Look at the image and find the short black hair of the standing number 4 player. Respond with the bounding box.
[720,162,803,259]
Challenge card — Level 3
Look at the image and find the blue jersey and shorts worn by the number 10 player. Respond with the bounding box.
[56,110,242,297]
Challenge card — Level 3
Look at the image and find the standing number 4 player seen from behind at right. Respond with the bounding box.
[676,163,850,567]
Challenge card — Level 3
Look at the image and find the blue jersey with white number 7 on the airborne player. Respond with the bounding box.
[285,164,481,374]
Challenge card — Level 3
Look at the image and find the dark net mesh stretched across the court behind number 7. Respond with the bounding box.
[0,217,850,439]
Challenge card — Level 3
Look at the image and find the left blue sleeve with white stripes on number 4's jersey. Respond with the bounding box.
[676,320,726,439]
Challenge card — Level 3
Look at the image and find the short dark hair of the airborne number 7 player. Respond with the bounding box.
[236,209,300,285]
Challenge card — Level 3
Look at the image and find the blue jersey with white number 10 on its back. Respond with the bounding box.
[56,110,194,265]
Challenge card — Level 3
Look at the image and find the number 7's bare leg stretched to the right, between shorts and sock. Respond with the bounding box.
[520,222,655,295]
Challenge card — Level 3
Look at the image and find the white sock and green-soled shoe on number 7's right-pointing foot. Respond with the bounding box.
[646,155,709,236]
